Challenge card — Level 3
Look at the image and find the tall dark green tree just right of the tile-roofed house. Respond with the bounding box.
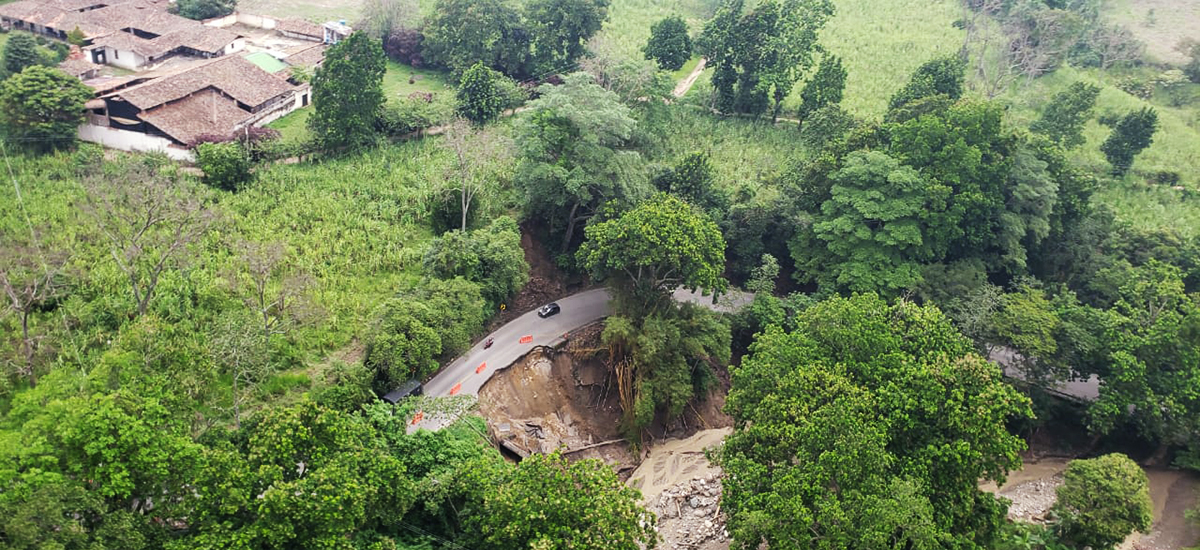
[308,32,386,149]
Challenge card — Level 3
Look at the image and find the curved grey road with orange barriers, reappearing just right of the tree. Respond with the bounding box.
[409,288,754,431]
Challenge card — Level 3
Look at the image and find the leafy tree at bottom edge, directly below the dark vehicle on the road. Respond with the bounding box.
[181,400,415,550]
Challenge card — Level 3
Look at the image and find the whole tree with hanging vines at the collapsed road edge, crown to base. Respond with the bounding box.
[577,193,730,435]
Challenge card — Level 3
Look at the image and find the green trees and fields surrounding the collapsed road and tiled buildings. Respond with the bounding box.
[0,0,1200,550]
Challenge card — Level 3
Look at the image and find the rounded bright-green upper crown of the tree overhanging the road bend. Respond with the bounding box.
[577,193,728,306]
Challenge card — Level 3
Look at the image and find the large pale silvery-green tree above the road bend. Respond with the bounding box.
[515,73,638,253]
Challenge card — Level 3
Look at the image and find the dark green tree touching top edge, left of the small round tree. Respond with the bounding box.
[524,0,608,74]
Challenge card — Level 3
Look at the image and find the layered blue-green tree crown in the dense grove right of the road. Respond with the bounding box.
[792,151,949,294]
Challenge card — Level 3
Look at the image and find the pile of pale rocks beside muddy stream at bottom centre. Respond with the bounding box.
[647,473,730,550]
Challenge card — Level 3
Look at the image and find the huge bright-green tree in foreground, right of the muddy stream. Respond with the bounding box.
[719,294,1031,549]
